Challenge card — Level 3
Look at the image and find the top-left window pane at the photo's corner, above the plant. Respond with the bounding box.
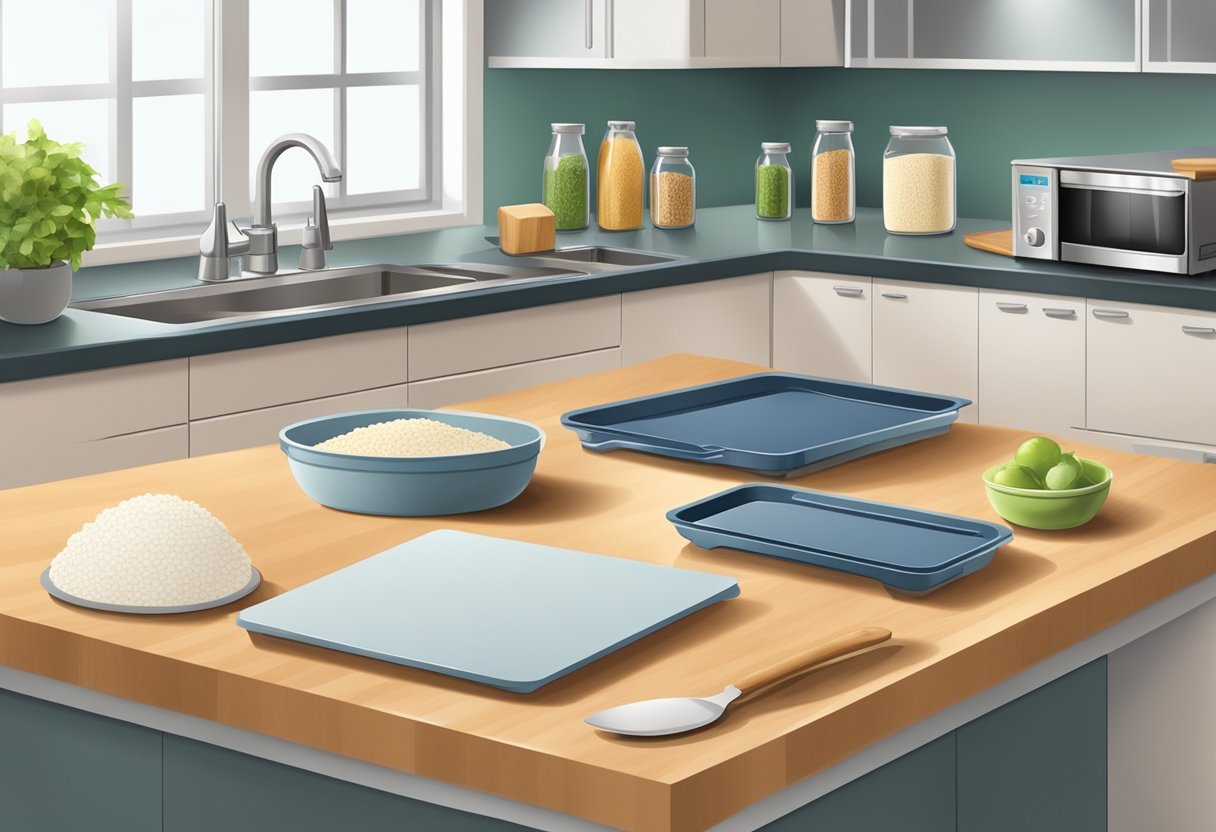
[0,0,113,86]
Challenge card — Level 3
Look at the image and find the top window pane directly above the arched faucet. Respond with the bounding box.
[249,0,334,78]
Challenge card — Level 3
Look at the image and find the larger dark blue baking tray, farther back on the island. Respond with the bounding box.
[562,372,970,477]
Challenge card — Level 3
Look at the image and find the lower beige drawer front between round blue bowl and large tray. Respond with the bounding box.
[409,349,620,407]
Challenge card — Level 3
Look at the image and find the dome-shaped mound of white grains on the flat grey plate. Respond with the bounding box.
[50,494,253,607]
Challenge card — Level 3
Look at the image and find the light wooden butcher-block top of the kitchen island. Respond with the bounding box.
[0,355,1216,832]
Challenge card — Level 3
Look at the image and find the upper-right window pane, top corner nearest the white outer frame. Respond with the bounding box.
[347,0,421,72]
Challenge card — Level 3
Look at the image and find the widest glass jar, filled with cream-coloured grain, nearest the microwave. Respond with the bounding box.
[883,127,957,234]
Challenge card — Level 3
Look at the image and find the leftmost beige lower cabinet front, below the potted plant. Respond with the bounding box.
[0,359,188,488]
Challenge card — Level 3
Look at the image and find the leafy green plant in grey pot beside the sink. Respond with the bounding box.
[0,119,131,324]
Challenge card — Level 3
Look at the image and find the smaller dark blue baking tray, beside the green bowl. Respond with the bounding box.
[668,483,1013,595]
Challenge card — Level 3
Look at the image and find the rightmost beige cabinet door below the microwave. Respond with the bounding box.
[1086,299,1216,445]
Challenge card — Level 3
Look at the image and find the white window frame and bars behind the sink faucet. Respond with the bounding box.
[85,0,484,266]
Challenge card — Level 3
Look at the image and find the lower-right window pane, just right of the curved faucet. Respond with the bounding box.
[345,85,422,193]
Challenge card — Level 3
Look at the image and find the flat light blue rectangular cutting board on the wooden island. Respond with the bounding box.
[236,529,739,693]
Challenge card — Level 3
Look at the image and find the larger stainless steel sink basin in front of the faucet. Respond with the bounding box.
[72,265,478,324]
